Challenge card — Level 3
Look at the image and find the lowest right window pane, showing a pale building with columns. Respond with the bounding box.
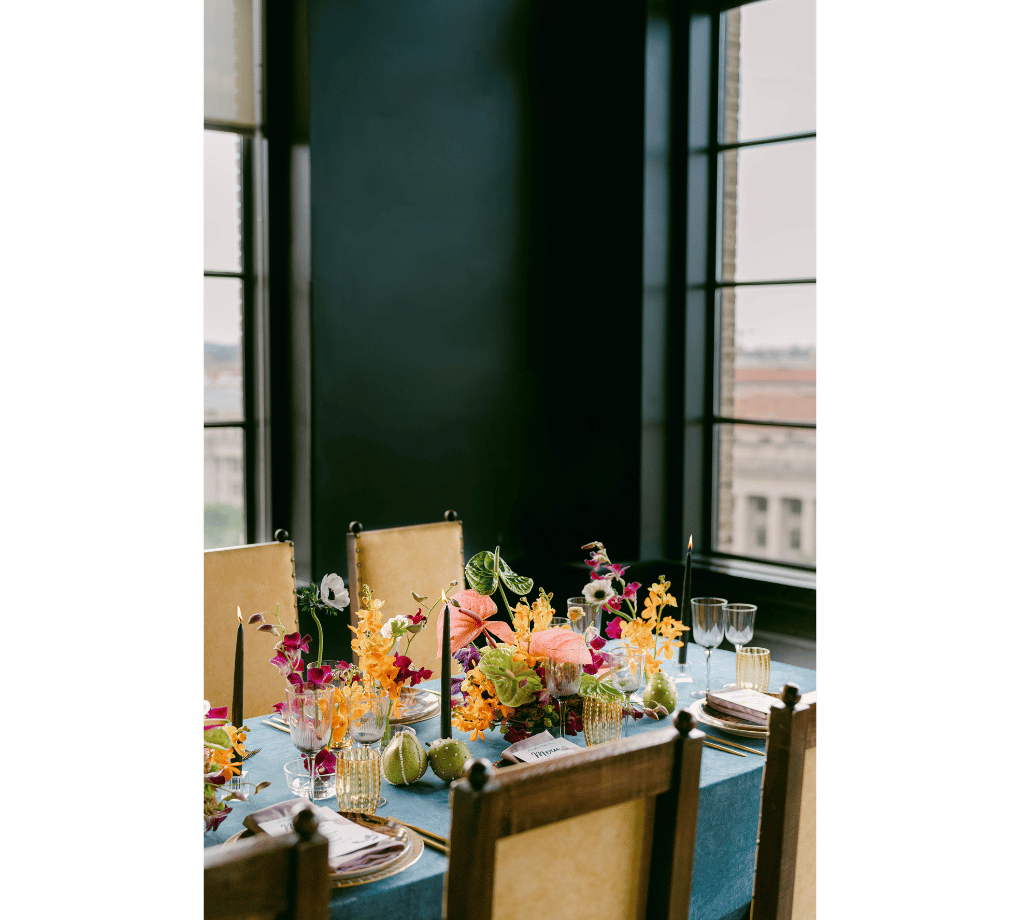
[715,424,818,565]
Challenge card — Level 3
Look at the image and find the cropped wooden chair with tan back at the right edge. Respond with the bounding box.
[751,683,818,920]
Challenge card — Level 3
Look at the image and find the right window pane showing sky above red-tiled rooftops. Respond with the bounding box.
[719,285,818,421]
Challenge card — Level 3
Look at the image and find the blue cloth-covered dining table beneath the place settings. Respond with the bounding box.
[203,646,817,920]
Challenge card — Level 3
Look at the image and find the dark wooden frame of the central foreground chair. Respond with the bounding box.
[444,710,705,920]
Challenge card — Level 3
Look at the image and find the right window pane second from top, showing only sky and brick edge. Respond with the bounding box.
[720,138,818,282]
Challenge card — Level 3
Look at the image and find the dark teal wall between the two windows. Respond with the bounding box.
[309,0,645,654]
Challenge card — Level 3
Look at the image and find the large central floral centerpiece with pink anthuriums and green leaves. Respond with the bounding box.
[437,547,599,742]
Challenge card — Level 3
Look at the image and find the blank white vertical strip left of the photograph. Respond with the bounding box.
[0,0,195,920]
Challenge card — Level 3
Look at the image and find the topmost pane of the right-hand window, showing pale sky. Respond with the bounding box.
[723,0,818,143]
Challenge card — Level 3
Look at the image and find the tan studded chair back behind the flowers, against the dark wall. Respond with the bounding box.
[347,511,464,677]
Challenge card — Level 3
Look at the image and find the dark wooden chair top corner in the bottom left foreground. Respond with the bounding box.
[202,809,332,920]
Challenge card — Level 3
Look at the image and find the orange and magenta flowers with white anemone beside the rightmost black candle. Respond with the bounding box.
[582,542,689,677]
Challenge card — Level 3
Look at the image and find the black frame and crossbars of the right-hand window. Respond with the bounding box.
[656,0,817,616]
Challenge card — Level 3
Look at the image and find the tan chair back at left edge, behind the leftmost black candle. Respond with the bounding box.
[202,542,298,719]
